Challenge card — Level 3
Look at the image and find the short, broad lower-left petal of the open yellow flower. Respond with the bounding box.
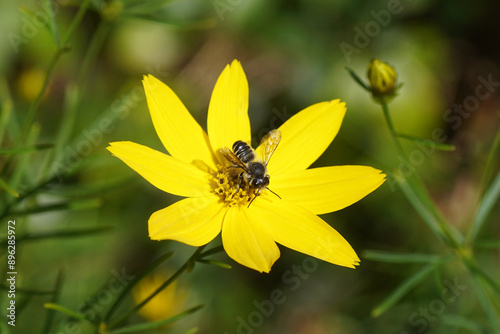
[149,196,226,246]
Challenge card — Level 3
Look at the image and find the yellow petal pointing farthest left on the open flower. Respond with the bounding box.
[107,141,213,197]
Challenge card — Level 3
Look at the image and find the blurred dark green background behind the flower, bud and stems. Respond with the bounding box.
[0,0,500,334]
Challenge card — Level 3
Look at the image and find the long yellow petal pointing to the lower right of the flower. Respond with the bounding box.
[254,196,359,268]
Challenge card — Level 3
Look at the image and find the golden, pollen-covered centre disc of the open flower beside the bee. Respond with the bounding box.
[214,166,256,206]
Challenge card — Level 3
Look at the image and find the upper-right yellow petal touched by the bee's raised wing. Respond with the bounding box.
[266,100,346,176]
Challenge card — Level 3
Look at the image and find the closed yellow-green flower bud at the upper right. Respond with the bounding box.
[367,59,397,98]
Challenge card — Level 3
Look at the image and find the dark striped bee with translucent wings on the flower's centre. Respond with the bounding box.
[220,129,281,207]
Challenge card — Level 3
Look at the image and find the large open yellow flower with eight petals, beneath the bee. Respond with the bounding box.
[108,60,385,272]
